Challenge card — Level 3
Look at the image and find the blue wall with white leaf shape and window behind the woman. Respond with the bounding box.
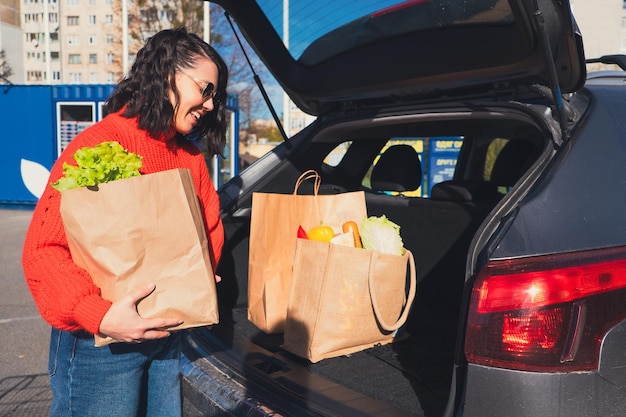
[0,84,239,206]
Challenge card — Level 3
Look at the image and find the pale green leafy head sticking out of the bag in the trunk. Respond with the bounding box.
[359,215,404,256]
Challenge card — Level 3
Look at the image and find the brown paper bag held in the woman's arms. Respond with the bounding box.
[60,169,219,346]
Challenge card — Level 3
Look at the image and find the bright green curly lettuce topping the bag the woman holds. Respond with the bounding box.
[51,141,142,191]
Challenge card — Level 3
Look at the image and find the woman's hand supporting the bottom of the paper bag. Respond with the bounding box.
[100,284,183,343]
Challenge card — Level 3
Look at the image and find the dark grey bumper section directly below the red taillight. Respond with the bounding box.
[463,321,626,417]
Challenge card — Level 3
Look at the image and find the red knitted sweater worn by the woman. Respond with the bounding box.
[22,113,224,334]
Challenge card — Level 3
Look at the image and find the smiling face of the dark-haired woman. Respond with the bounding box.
[169,57,218,135]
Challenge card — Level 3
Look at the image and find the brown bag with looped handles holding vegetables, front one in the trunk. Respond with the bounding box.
[283,239,417,362]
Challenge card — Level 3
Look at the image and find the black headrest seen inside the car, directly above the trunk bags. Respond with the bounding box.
[371,144,422,193]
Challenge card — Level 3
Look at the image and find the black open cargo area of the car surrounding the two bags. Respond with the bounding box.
[183,99,557,416]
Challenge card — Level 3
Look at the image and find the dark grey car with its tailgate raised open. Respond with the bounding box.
[182,0,626,417]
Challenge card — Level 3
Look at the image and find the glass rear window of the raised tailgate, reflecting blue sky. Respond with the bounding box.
[258,0,514,65]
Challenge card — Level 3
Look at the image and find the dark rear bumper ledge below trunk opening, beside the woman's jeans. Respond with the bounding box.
[181,330,423,417]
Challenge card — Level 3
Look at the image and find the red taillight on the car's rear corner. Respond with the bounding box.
[465,244,626,372]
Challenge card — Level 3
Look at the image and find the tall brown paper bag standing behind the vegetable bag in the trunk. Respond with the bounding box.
[248,171,367,333]
